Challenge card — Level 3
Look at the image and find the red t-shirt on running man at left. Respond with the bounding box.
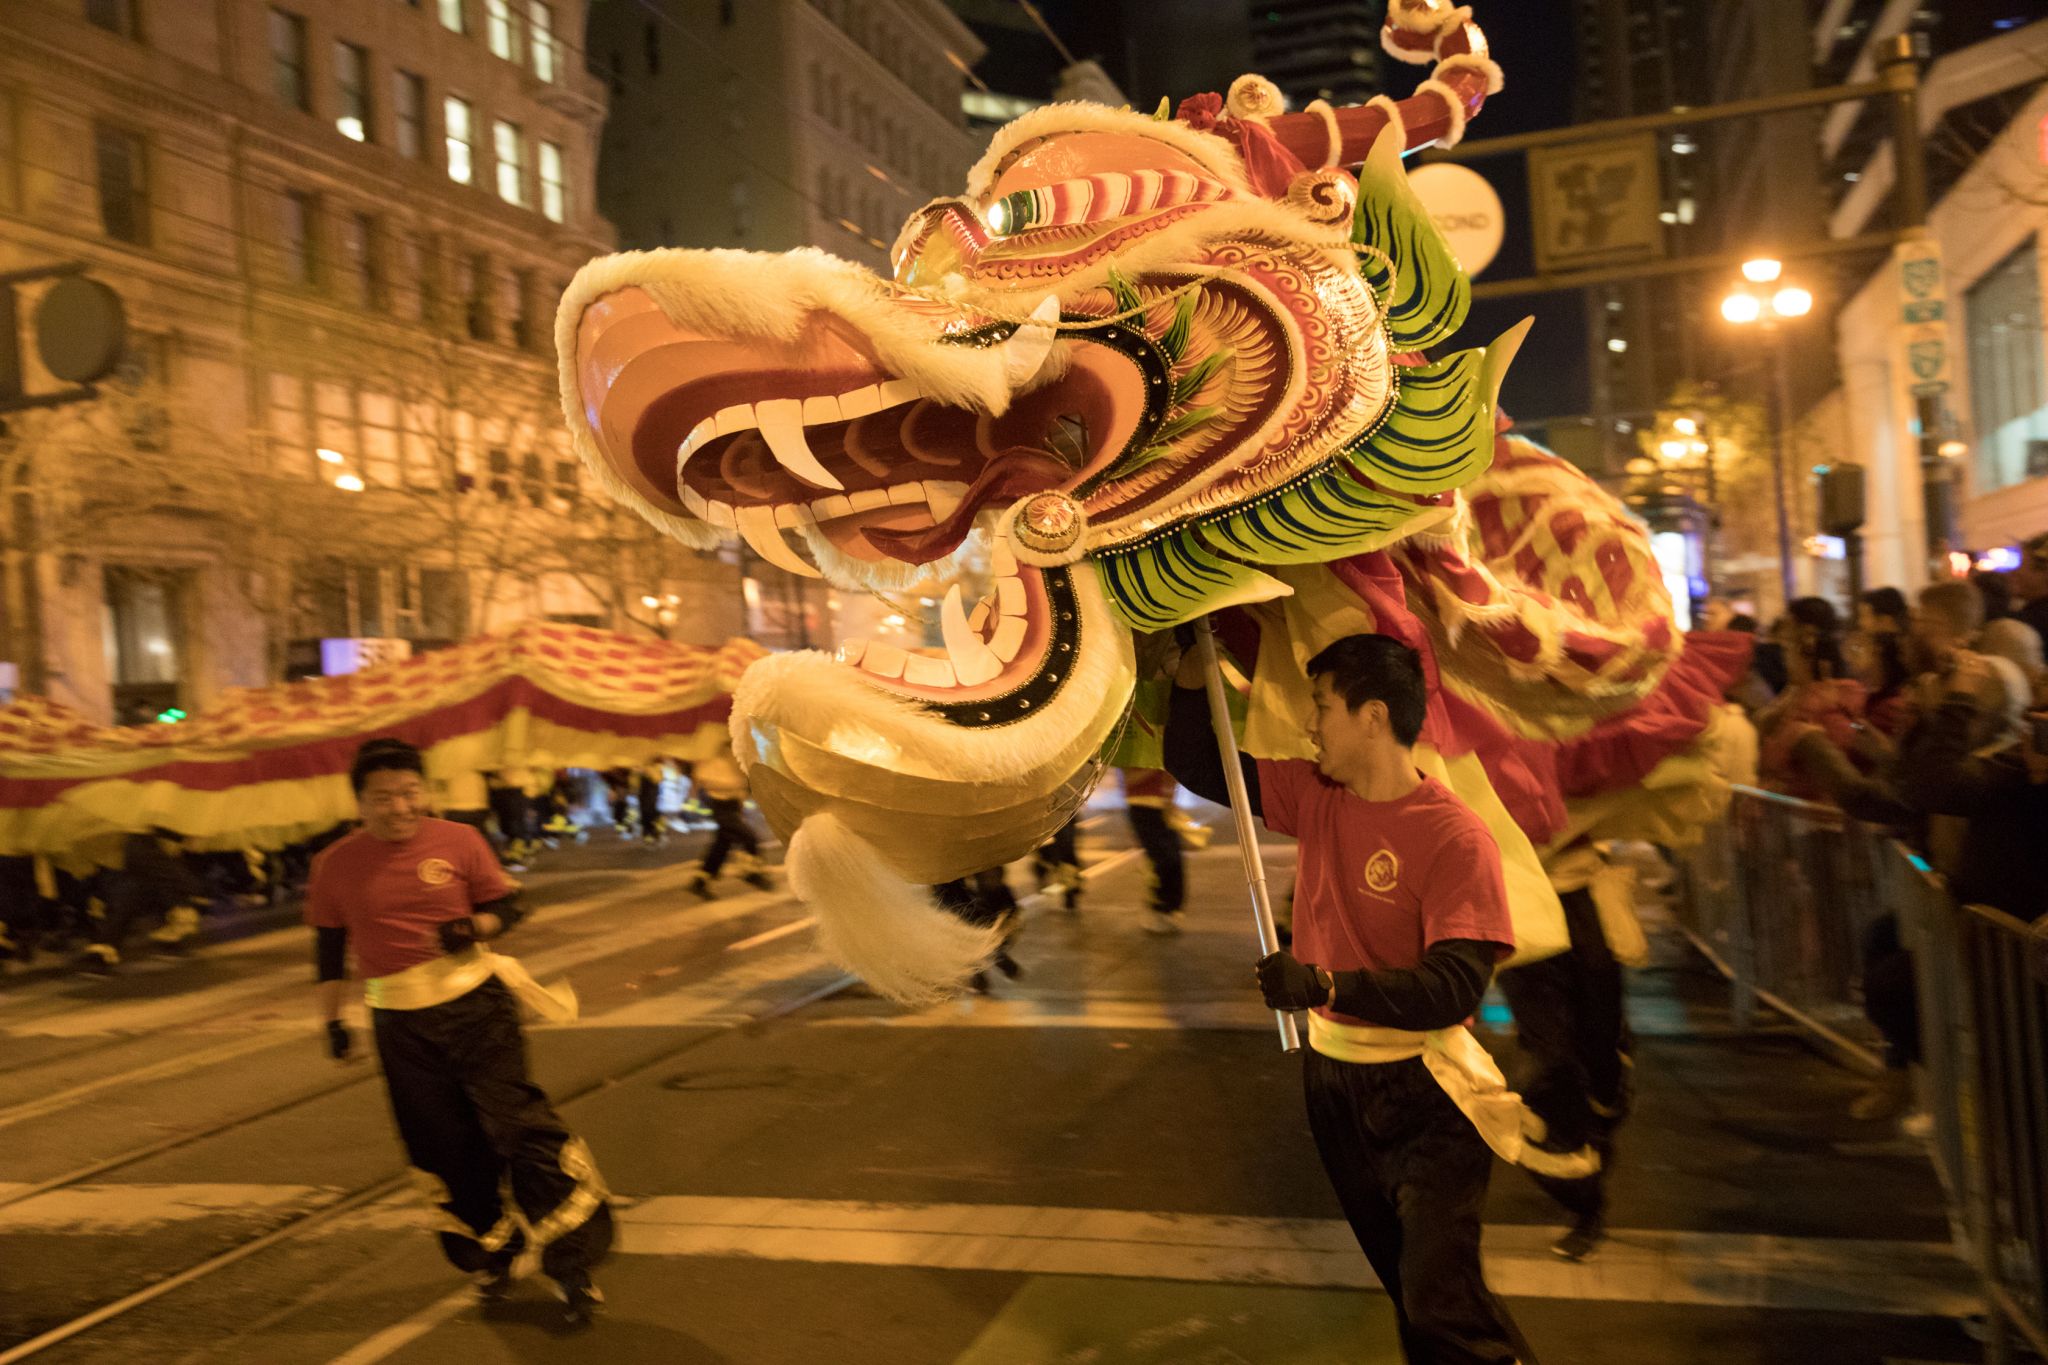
[305,819,516,976]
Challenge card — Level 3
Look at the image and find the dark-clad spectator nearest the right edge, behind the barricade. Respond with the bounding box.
[1901,655,2048,921]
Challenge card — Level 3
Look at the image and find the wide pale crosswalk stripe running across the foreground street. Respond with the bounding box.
[12,1185,1980,1326]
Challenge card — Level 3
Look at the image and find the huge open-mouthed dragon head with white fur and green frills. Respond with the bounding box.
[557,0,1513,999]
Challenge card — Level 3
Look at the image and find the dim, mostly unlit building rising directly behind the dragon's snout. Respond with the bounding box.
[590,0,981,266]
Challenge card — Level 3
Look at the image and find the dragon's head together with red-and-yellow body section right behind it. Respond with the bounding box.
[557,0,1747,1003]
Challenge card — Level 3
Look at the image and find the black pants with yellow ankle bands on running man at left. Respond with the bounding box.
[371,980,612,1283]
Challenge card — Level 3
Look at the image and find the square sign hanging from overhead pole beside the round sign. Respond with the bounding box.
[1530,133,1663,274]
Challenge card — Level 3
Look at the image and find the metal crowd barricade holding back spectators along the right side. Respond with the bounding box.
[1677,788,2048,1365]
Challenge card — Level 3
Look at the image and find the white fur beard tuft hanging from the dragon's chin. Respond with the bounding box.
[786,810,1001,1007]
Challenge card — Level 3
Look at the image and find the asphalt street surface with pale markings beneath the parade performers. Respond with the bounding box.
[0,810,1978,1365]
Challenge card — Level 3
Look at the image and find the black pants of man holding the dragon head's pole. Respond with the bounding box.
[1300,1048,1536,1365]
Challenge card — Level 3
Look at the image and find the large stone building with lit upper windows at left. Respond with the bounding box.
[0,0,737,718]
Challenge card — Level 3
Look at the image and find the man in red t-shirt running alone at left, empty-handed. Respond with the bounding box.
[305,739,612,1326]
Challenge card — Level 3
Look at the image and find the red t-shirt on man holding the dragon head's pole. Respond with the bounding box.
[1260,759,1516,1023]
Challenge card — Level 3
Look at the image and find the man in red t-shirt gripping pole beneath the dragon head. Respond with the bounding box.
[1165,634,1536,1365]
